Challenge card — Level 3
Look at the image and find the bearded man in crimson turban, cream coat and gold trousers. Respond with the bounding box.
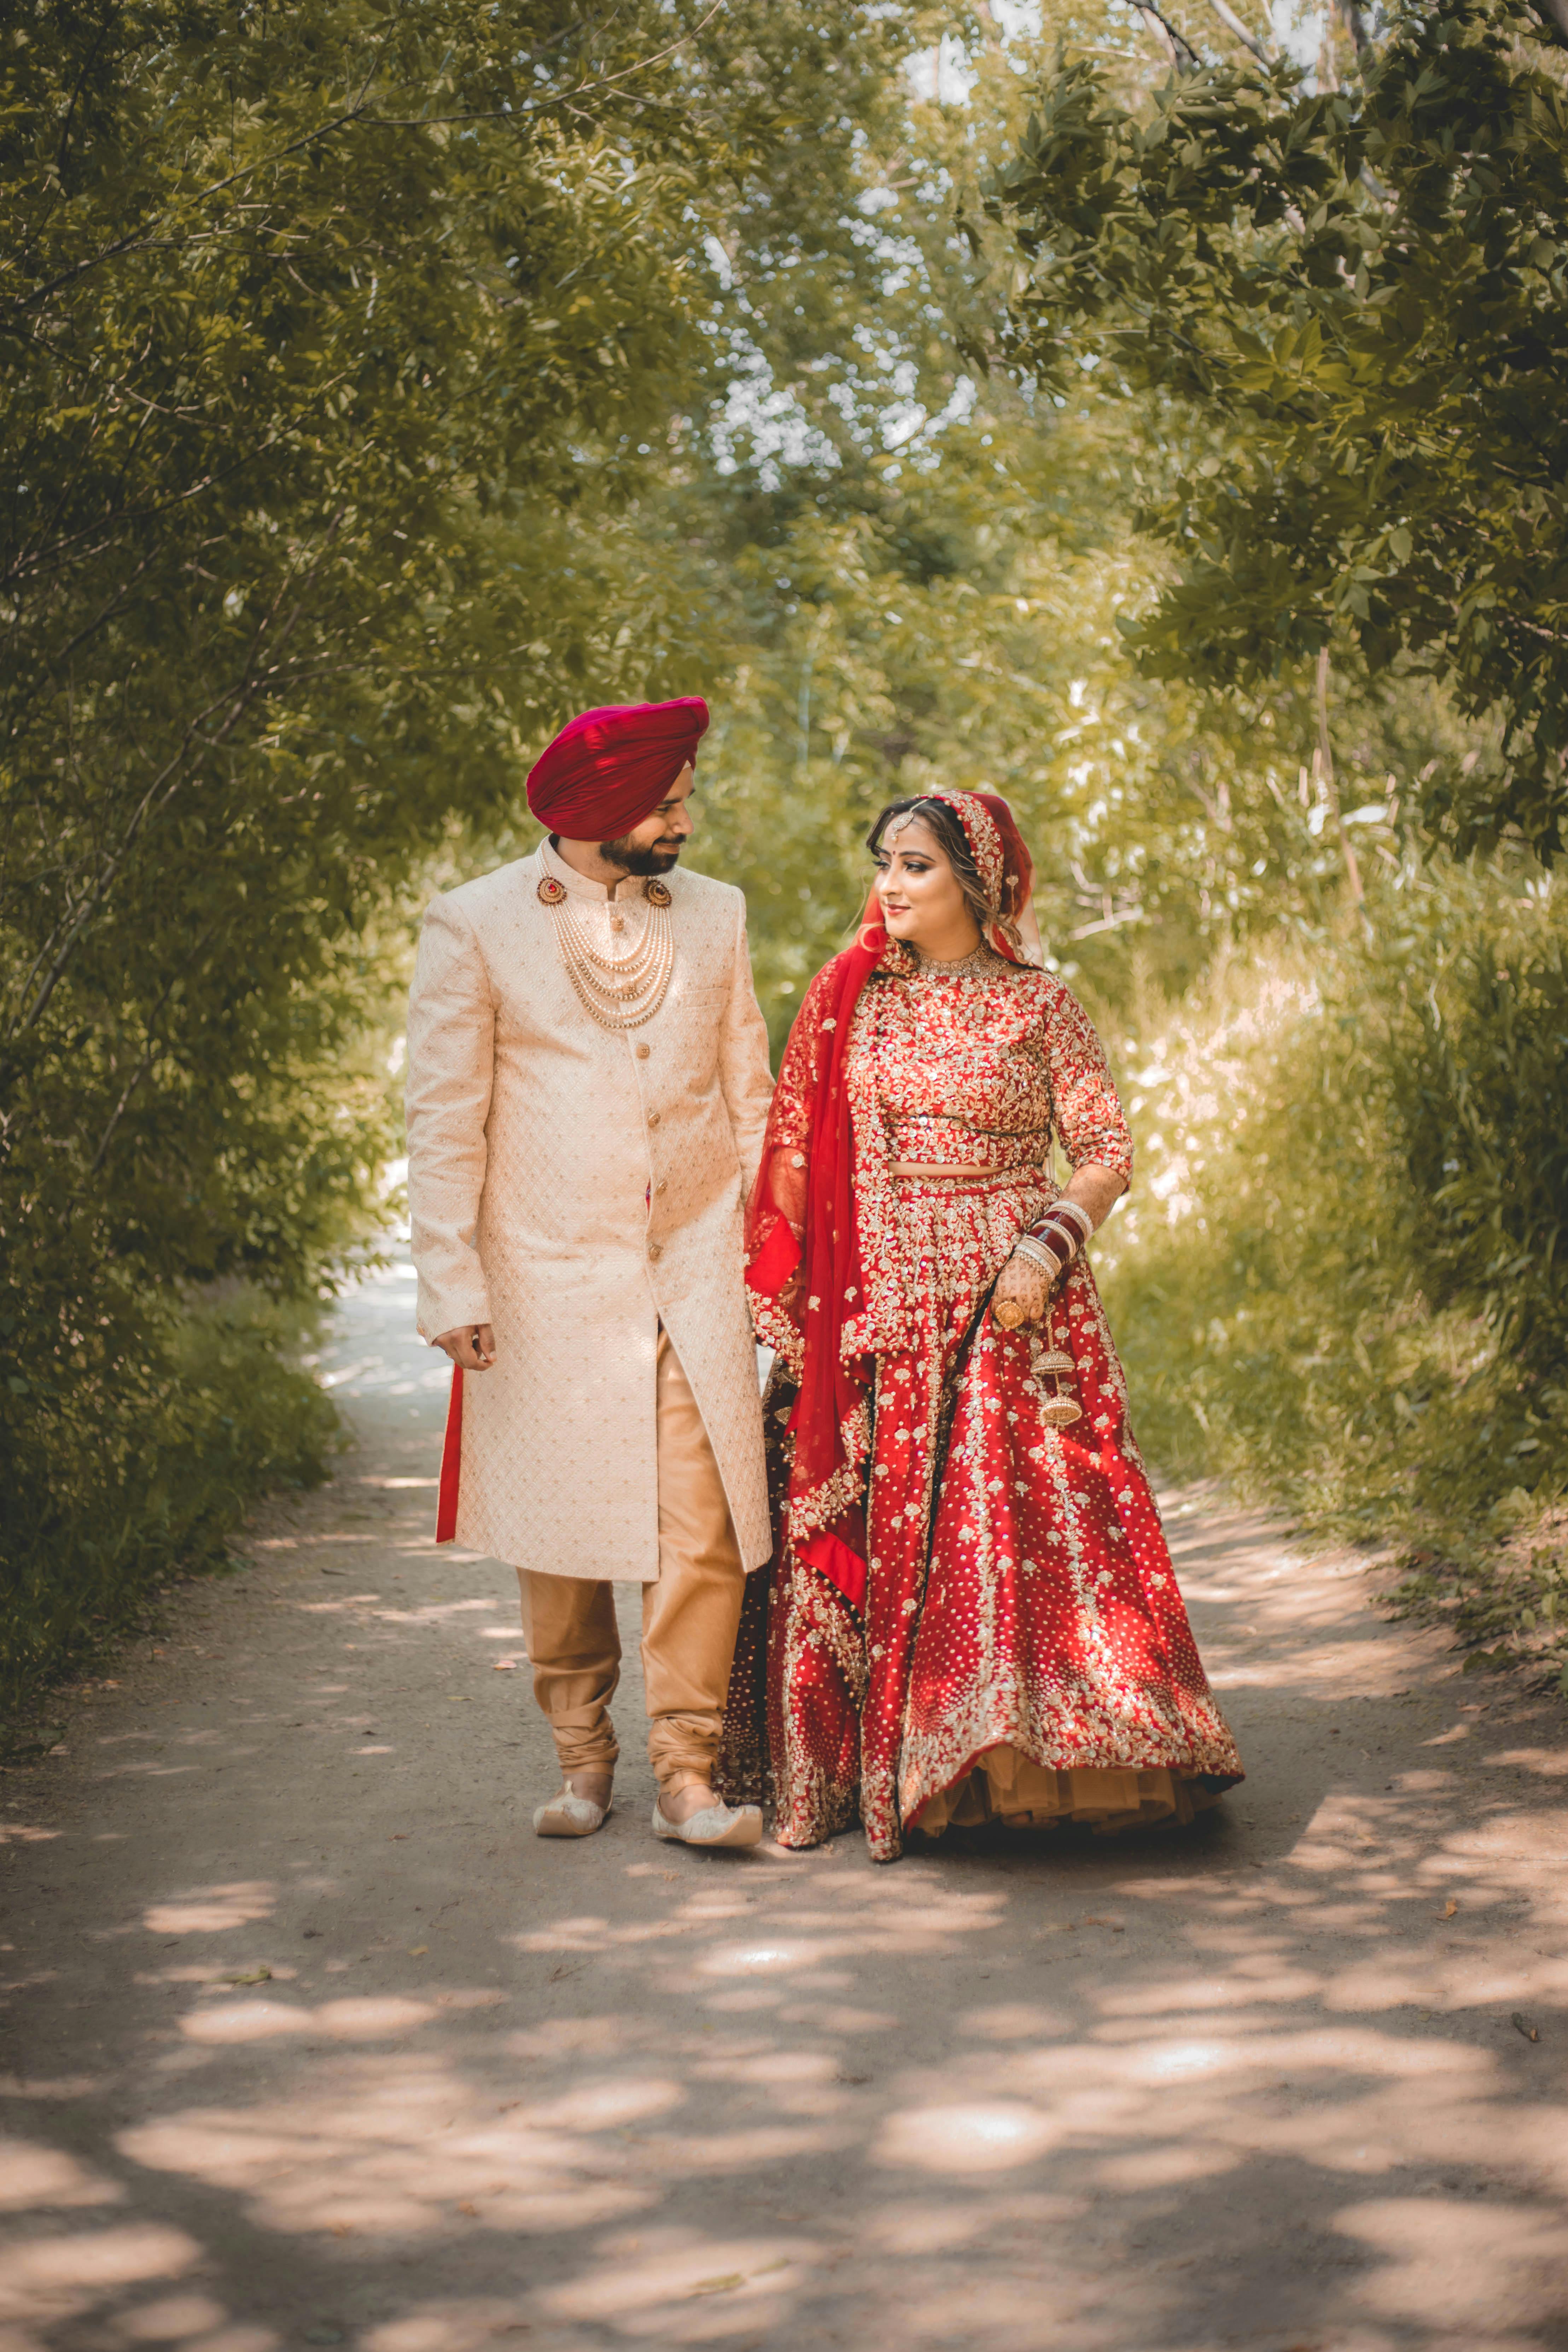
[407,699,774,1846]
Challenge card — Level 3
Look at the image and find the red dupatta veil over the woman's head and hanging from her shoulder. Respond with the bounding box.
[745,788,1034,1611]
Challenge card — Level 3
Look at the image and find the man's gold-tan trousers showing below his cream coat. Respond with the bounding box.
[517,1324,745,1794]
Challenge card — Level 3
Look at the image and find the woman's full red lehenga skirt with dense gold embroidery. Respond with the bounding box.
[724,1169,1241,1861]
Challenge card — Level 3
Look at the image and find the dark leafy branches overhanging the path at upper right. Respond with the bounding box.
[990,0,1568,858]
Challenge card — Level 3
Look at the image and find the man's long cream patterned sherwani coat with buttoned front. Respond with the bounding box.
[407,842,774,1585]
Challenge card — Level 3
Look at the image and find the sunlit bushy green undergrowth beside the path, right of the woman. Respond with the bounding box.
[1107,863,1568,1675]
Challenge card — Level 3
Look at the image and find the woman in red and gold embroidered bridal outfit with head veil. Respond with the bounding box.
[727,790,1241,1861]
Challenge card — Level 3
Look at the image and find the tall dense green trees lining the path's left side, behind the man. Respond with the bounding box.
[0,0,931,1712]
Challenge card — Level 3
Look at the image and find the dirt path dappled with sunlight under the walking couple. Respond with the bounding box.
[0,1277,1568,2352]
